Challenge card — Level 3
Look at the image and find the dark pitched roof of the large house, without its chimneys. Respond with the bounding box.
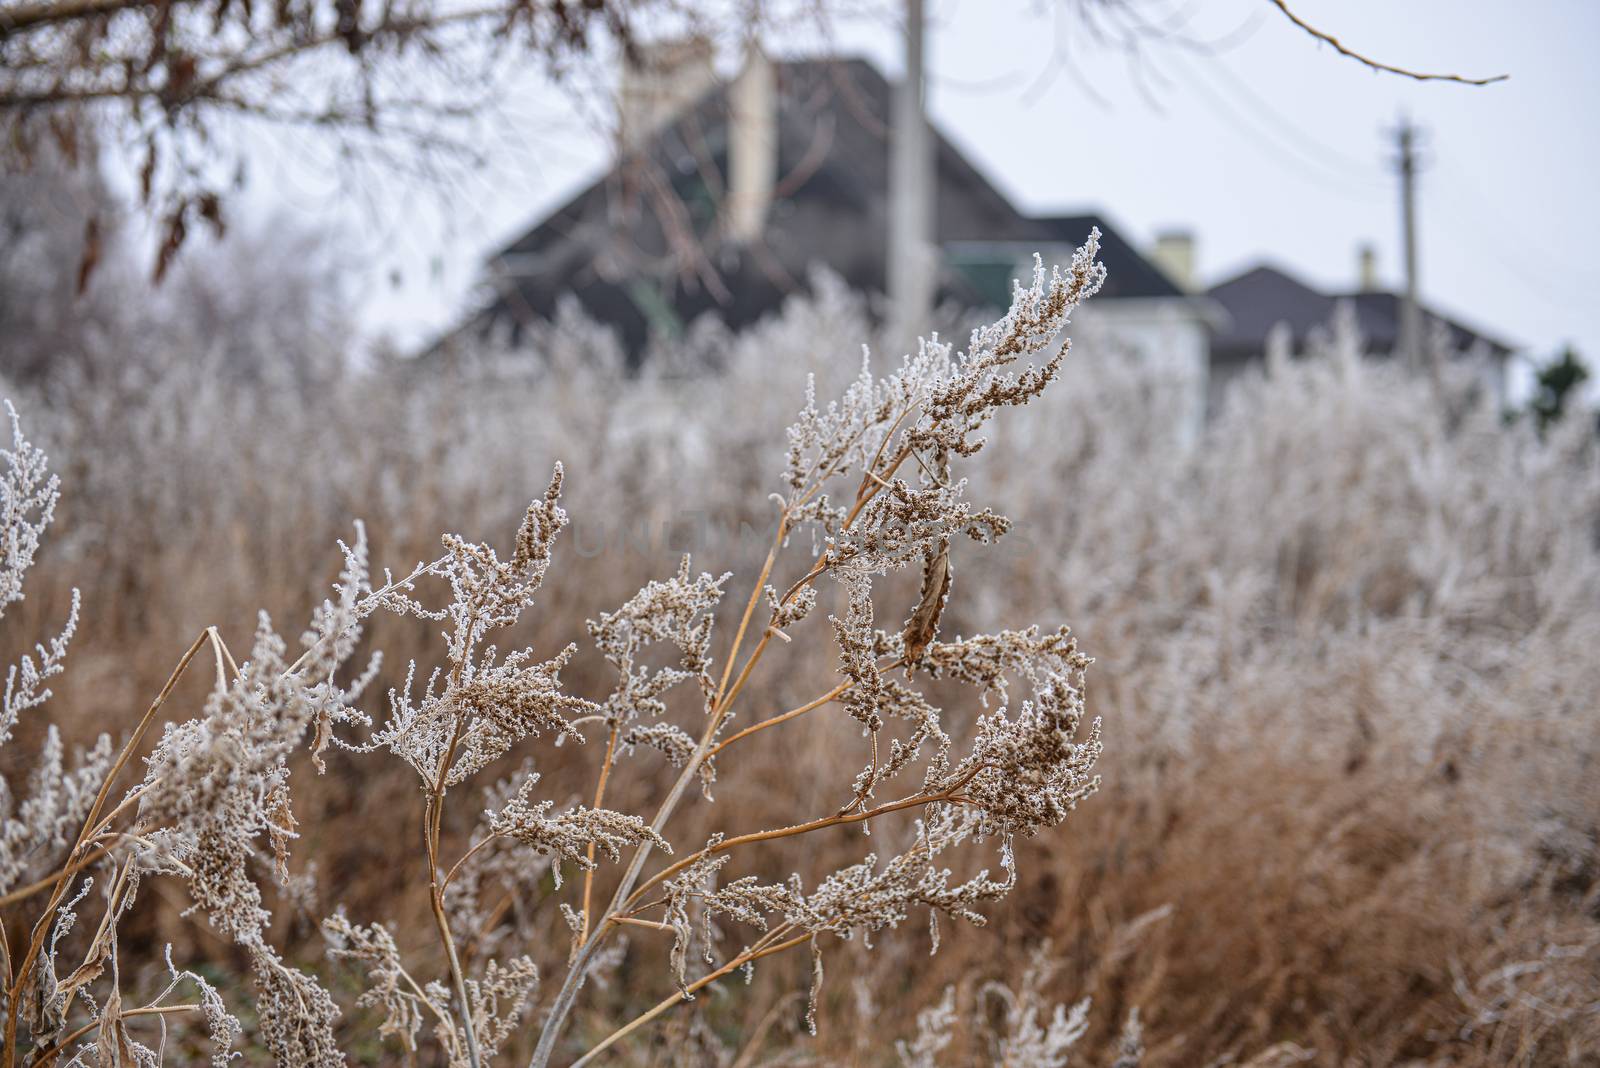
[464,59,1178,357]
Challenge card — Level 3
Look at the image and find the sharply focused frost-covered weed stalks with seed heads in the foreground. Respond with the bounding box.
[0,233,1104,1068]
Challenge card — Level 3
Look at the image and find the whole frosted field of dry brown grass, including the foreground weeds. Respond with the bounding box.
[0,241,1600,1068]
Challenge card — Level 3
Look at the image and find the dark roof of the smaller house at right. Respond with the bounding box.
[1206,264,1512,361]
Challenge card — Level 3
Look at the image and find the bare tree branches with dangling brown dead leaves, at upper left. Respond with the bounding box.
[0,0,681,278]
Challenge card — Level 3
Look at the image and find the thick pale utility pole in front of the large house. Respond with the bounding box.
[886,0,938,344]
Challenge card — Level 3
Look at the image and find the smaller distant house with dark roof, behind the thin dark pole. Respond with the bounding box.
[1206,259,1514,401]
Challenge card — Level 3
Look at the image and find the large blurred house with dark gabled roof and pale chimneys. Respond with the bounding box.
[462,42,1216,428]
